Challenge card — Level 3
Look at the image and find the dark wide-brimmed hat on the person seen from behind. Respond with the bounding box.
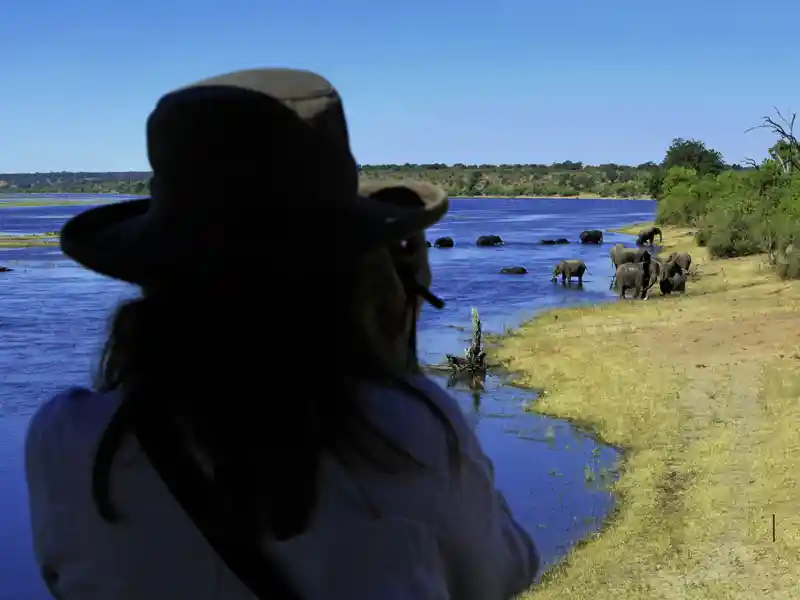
[61,69,448,285]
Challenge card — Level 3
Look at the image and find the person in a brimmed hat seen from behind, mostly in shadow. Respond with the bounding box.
[25,69,539,600]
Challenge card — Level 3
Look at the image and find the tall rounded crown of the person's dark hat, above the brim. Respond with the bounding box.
[147,69,358,208]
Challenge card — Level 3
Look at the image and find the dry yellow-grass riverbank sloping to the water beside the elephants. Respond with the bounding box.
[495,224,800,600]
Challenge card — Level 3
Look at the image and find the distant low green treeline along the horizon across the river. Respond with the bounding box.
[0,146,752,198]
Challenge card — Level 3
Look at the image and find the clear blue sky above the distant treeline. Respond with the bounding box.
[0,0,800,172]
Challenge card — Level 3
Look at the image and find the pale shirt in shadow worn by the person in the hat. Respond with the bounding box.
[25,376,539,600]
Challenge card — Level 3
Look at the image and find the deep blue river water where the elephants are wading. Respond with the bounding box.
[0,196,655,600]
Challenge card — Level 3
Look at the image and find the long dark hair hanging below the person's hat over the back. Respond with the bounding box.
[92,266,457,539]
